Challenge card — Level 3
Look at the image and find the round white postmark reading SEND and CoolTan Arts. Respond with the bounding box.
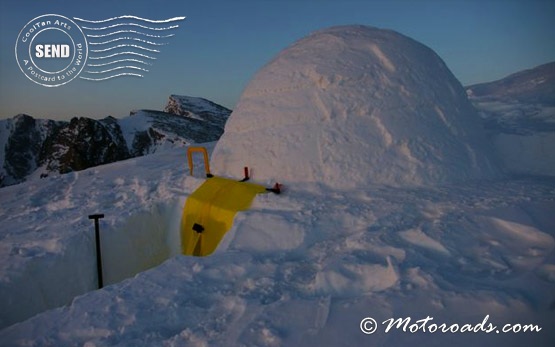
[15,14,88,87]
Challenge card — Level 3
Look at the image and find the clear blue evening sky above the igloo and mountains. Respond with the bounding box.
[0,0,555,120]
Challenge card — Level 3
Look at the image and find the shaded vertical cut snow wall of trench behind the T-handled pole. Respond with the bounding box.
[0,199,183,329]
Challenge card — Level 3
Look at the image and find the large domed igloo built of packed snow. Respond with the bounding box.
[211,26,497,189]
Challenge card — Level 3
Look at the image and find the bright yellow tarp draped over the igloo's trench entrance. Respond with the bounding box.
[181,177,266,256]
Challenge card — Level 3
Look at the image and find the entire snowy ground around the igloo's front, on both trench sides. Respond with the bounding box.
[0,146,555,347]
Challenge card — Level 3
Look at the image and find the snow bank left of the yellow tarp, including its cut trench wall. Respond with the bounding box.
[0,147,210,332]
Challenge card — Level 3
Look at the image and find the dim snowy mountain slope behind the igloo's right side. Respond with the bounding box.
[467,62,555,176]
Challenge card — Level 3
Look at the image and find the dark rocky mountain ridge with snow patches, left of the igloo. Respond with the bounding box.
[0,95,231,187]
